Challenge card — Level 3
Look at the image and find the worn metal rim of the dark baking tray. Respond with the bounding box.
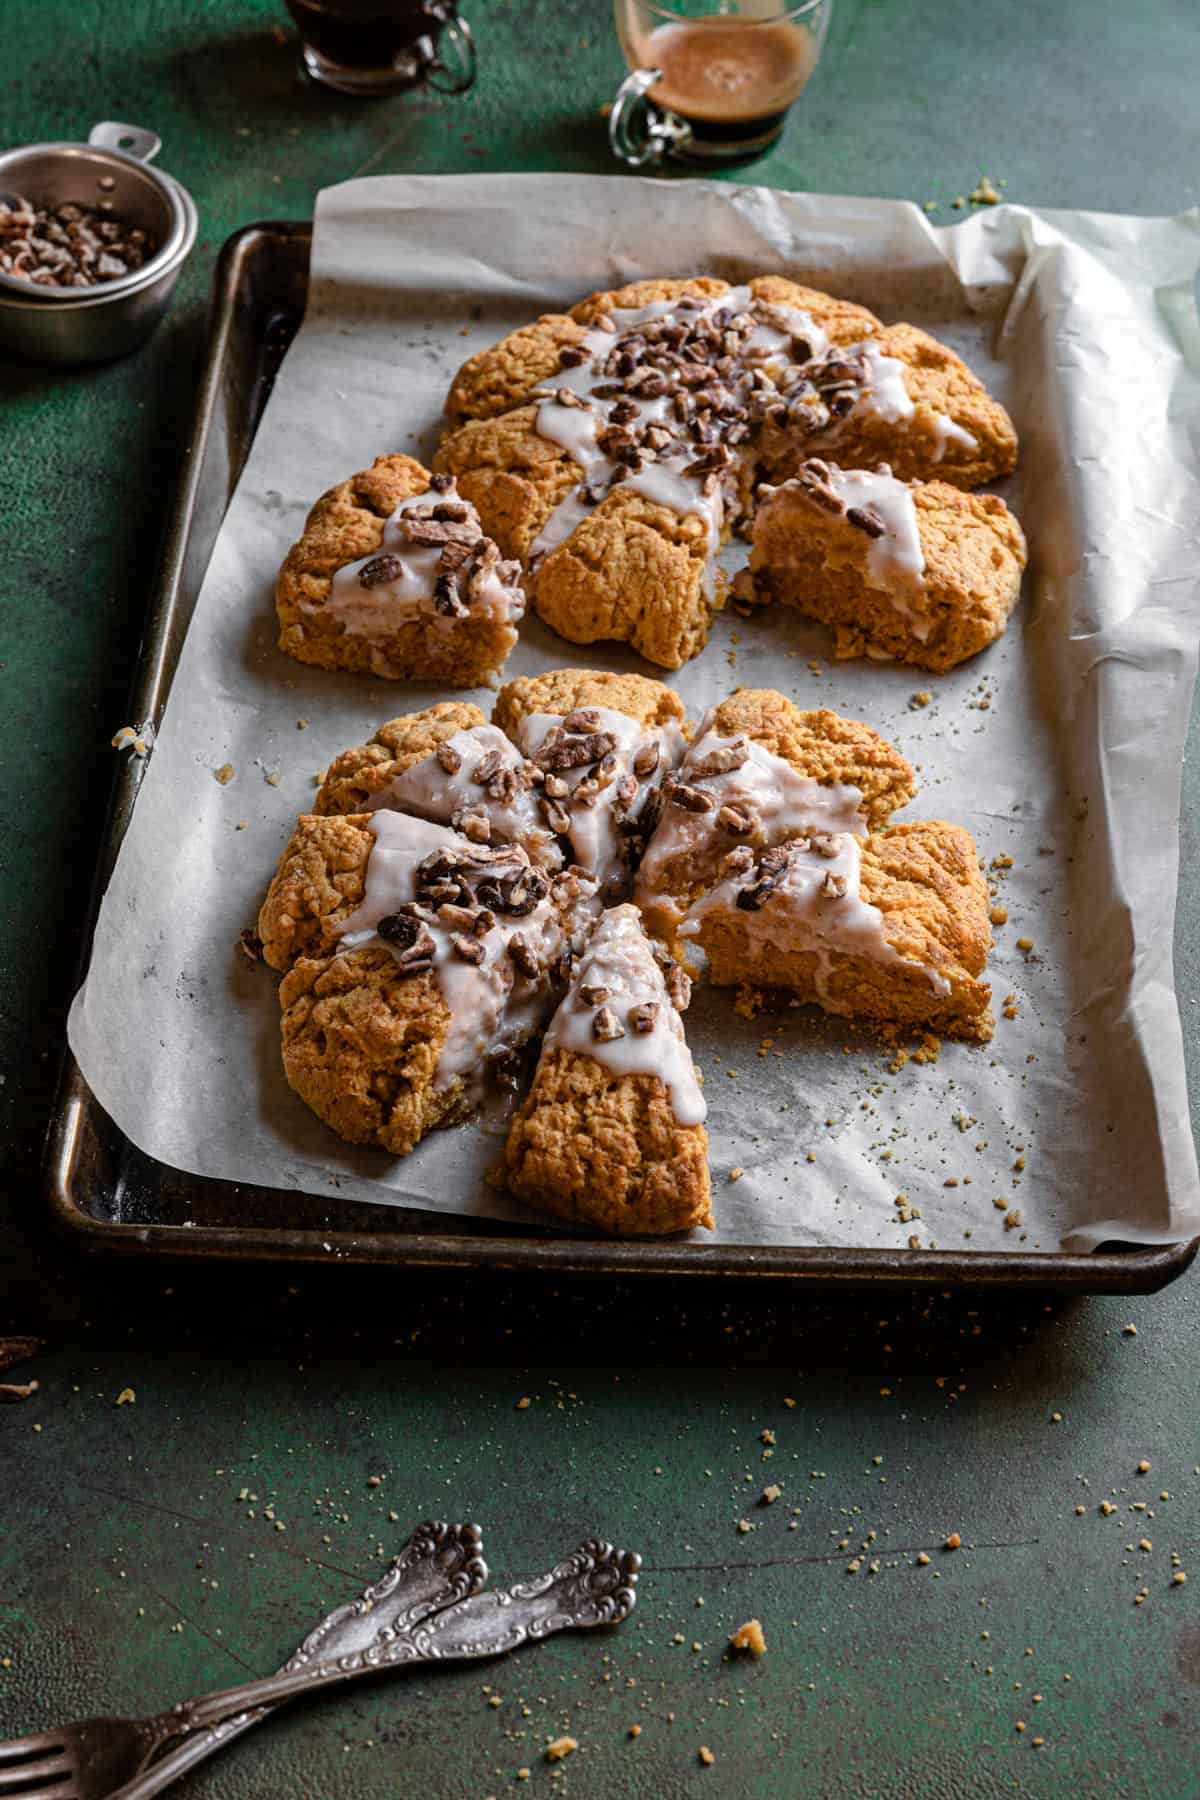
[43,220,1200,1292]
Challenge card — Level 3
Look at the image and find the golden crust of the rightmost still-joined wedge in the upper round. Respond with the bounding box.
[761,326,1016,488]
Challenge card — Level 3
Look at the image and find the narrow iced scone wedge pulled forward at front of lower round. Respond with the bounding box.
[504,905,712,1237]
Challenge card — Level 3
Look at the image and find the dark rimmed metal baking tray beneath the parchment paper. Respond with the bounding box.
[45,221,1200,1294]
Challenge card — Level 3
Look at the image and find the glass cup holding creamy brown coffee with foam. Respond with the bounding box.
[608,0,833,167]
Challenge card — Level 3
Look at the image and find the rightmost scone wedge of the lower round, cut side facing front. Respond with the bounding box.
[680,821,993,1042]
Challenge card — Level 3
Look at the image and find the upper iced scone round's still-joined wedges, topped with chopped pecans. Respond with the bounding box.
[435,277,1016,668]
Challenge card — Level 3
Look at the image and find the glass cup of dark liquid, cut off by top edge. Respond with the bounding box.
[286,0,475,95]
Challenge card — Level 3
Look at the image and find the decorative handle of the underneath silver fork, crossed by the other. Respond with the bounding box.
[110,1521,488,1800]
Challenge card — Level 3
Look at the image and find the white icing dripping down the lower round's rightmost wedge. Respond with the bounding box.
[680,832,950,1013]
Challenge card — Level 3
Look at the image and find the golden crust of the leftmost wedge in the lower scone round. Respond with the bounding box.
[259,814,374,968]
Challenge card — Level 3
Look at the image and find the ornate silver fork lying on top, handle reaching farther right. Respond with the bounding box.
[0,1537,640,1800]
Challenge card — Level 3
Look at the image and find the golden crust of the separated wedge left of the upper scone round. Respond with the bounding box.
[275,454,513,688]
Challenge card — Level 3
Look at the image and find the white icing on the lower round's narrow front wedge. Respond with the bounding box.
[542,905,707,1125]
